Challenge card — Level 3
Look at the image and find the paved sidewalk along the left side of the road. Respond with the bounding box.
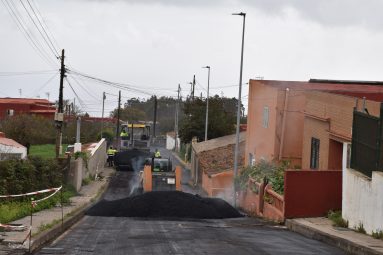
[0,168,115,255]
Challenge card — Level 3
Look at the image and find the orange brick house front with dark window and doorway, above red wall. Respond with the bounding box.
[302,90,383,170]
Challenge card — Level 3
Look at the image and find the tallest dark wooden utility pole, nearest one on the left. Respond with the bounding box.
[55,49,65,158]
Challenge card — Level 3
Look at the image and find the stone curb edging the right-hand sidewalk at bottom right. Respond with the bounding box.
[285,219,383,255]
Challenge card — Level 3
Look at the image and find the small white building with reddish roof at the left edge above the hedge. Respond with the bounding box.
[0,132,27,161]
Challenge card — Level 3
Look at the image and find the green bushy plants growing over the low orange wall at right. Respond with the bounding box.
[235,160,290,195]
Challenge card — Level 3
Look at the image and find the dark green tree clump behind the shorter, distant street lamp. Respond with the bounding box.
[179,95,237,143]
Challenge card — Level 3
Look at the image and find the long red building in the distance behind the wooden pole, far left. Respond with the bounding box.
[0,98,56,120]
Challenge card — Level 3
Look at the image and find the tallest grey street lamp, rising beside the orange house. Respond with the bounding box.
[233,12,246,207]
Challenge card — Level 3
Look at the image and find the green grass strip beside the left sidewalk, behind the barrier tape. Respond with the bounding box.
[0,186,77,224]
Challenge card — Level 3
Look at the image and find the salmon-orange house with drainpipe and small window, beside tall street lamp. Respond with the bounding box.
[245,80,383,168]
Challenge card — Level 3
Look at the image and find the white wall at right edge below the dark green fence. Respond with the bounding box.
[342,143,383,234]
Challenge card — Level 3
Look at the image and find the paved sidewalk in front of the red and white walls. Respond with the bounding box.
[286,217,383,255]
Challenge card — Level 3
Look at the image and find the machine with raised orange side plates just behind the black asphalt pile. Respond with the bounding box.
[140,157,182,192]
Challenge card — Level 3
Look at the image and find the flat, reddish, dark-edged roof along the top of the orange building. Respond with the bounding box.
[252,79,383,102]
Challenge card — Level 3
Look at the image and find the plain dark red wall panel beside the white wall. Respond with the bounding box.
[284,170,342,219]
